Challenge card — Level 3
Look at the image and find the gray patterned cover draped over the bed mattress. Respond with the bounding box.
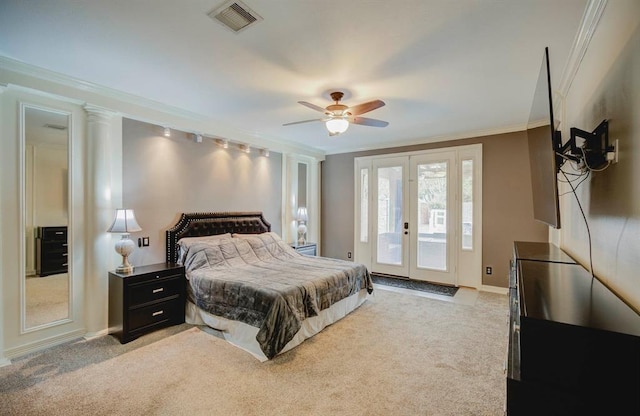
[178,232,373,359]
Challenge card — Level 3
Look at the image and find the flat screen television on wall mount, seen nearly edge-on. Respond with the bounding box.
[527,48,562,228]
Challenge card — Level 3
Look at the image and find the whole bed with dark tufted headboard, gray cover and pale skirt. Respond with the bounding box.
[166,212,373,361]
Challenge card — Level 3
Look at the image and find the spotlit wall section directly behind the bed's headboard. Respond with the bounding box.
[122,119,282,266]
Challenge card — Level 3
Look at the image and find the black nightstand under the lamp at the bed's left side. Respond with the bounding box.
[109,263,185,344]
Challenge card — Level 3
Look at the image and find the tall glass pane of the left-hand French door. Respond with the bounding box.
[376,166,402,265]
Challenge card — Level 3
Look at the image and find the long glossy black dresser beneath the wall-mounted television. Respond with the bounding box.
[506,242,640,416]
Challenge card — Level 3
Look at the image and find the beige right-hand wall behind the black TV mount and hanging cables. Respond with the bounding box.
[560,1,640,311]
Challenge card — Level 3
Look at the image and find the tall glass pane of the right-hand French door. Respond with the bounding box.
[417,162,448,271]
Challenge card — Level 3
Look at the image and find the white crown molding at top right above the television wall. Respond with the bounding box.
[557,0,607,98]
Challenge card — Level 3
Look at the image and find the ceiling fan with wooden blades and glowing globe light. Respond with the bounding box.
[283,91,389,136]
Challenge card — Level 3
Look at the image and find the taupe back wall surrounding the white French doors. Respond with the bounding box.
[321,132,548,287]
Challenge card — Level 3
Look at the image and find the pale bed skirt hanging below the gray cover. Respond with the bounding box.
[185,289,369,362]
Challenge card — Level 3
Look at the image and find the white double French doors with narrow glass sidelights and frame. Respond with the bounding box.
[355,145,482,287]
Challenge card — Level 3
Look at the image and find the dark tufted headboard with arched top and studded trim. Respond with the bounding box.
[166,212,271,263]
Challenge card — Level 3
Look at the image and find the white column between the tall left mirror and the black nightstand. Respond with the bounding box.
[84,105,120,338]
